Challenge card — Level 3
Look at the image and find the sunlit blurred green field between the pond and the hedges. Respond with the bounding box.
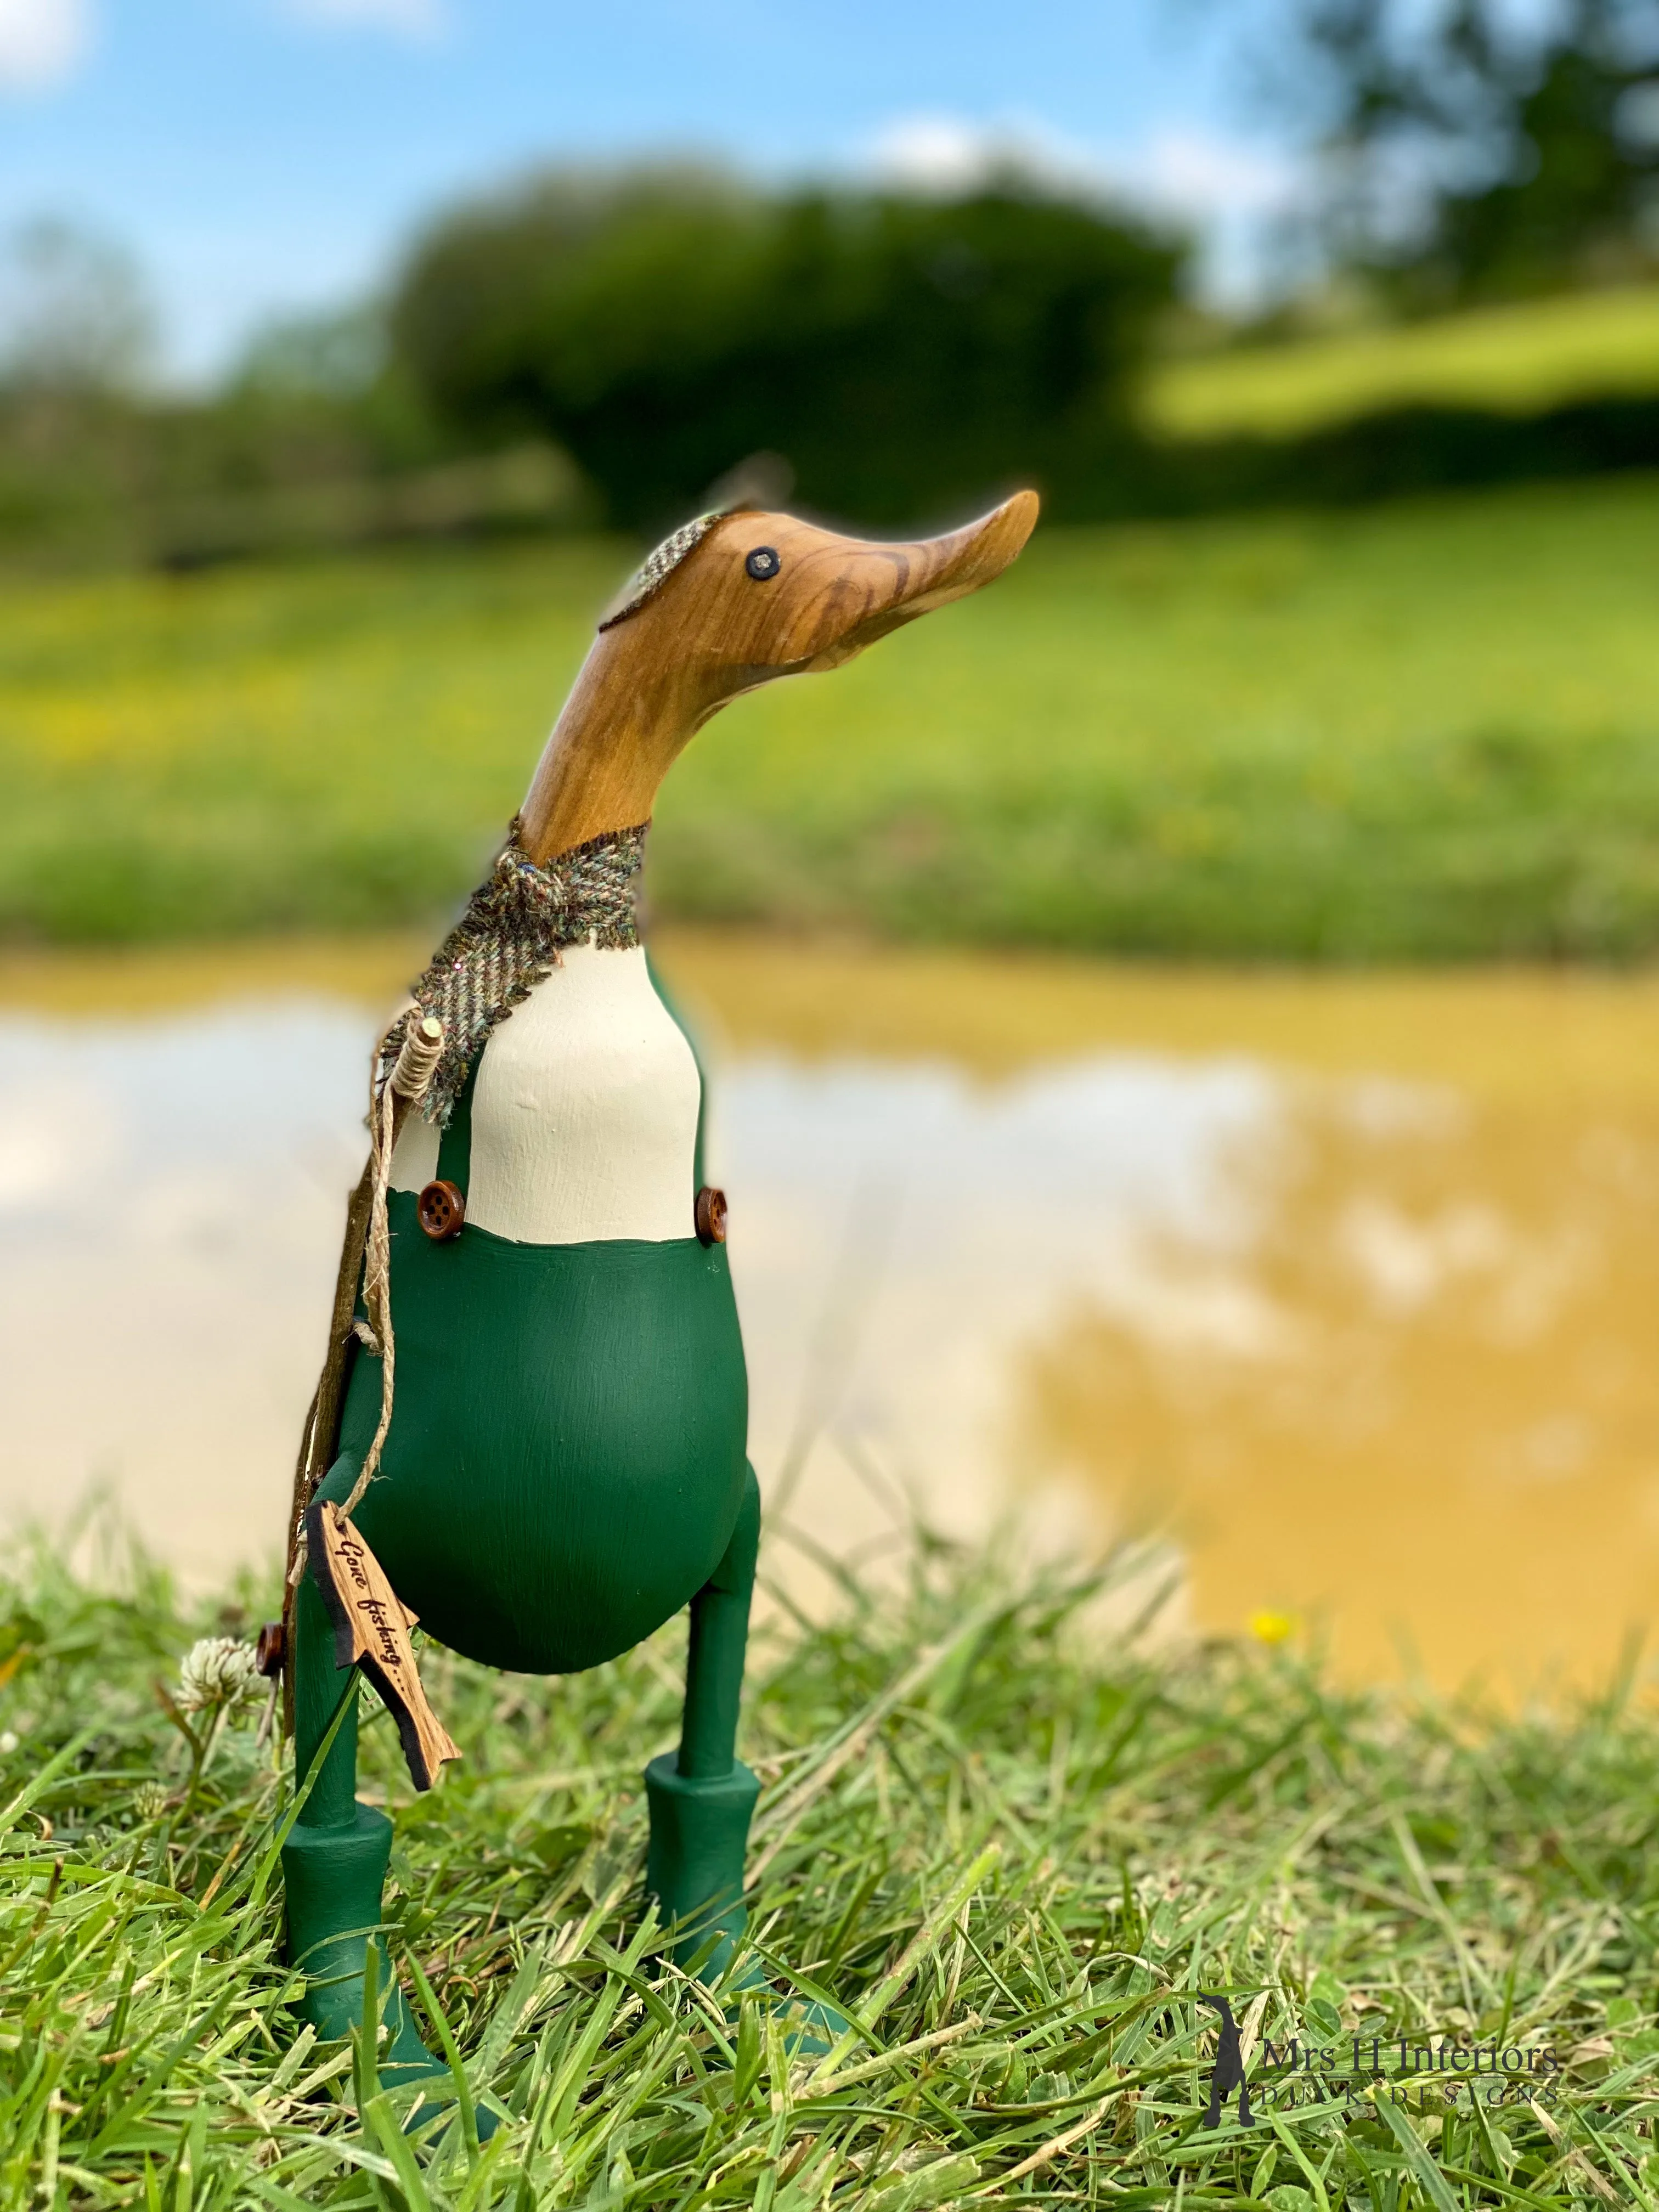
[0,478,1659,960]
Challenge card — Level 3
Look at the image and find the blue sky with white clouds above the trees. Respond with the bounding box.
[0,0,1296,381]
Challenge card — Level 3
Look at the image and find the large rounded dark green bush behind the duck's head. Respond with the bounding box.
[390,168,1181,524]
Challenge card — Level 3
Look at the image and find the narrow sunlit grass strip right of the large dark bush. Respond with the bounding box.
[1142,285,1659,438]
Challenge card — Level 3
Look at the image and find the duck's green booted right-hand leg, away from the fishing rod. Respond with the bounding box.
[646,1469,761,1982]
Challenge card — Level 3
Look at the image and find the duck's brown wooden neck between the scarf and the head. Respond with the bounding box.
[520,624,708,865]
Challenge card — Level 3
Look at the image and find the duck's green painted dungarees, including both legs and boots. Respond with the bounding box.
[283,986,759,2079]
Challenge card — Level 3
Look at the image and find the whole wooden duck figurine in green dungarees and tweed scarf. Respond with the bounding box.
[283,491,1037,2079]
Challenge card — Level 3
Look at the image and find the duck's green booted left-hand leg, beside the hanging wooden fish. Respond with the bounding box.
[283,1458,444,2088]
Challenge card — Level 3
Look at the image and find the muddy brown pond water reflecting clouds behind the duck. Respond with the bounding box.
[0,931,1659,1695]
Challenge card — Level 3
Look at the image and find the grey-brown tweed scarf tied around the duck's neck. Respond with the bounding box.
[378,823,650,1128]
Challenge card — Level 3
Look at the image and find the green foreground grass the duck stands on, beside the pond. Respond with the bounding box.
[0,1544,1659,2212]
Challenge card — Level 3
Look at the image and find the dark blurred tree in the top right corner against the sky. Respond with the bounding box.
[1296,0,1659,309]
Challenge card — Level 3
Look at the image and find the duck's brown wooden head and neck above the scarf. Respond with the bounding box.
[520,491,1037,860]
